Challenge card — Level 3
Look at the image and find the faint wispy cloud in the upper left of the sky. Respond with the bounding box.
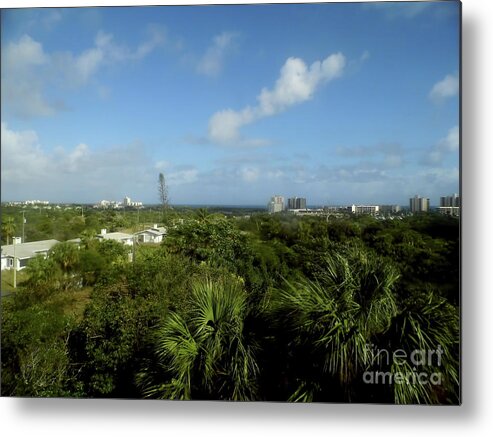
[1,28,165,118]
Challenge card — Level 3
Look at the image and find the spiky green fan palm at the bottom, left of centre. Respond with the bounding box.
[138,279,259,400]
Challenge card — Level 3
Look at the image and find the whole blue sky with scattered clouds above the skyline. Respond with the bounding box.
[1,1,459,205]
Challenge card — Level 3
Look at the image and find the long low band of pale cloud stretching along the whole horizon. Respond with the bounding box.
[0,119,459,204]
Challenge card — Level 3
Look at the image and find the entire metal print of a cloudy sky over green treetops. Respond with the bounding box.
[1,1,461,405]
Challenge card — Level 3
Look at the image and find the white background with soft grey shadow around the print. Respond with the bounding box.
[0,0,493,437]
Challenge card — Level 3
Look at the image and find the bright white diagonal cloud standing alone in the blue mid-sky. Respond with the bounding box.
[209,53,346,146]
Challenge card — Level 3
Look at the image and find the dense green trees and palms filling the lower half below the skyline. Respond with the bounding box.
[1,206,460,404]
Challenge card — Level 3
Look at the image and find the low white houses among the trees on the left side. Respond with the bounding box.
[1,223,166,271]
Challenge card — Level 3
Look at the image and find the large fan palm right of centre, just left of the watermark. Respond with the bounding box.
[270,249,399,401]
